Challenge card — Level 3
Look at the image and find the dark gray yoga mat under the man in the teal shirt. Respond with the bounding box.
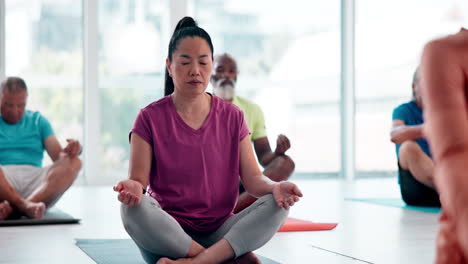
[0,208,80,227]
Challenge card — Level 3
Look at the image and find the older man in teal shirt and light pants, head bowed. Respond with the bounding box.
[0,77,81,220]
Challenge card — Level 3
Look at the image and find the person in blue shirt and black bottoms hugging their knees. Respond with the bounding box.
[390,69,440,206]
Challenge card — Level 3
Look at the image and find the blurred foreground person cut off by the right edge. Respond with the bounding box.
[421,29,468,264]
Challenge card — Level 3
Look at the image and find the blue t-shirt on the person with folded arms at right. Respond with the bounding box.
[392,101,431,157]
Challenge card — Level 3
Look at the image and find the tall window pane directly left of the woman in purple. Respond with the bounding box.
[95,0,169,182]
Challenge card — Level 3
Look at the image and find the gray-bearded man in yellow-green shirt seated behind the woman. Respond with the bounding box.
[211,53,295,213]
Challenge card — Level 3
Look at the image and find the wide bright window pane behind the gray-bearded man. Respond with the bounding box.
[192,0,340,173]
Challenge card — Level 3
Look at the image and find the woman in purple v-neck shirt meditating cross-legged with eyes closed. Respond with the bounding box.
[115,17,302,264]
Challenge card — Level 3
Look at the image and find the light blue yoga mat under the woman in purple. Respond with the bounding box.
[76,239,280,264]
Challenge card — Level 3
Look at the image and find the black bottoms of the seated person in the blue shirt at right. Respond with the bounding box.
[398,164,440,207]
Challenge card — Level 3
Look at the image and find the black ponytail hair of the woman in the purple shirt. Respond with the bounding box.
[164,17,213,96]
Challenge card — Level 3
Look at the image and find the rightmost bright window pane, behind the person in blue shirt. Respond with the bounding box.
[356,0,468,171]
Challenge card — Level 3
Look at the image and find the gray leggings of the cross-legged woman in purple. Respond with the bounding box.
[120,194,289,264]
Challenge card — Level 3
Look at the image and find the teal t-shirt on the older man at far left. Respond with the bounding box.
[0,110,54,167]
